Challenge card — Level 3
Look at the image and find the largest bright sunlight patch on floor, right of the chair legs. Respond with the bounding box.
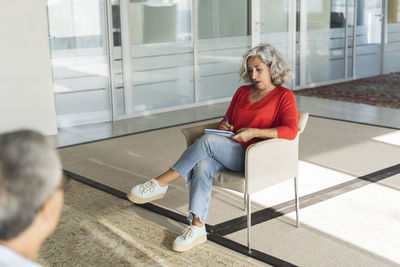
[288,179,400,263]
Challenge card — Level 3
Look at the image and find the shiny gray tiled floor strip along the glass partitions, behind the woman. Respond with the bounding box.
[57,96,400,147]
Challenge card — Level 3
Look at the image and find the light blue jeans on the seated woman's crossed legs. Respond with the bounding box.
[171,134,246,223]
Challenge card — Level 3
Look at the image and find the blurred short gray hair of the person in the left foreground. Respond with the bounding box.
[0,130,61,241]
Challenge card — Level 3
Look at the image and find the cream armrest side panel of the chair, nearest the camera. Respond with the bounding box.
[245,134,299,194]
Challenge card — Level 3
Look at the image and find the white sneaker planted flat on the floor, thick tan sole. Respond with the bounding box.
[172,224,207,252]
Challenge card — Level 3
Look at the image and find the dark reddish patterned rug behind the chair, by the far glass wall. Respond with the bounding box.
[294,72,400,109]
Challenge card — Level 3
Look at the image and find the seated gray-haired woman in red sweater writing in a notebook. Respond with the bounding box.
[128,44,298,251]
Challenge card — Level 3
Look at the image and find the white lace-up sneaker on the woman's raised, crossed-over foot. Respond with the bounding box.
[127,179,168,204]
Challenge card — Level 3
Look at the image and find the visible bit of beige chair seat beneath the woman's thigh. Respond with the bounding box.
[213,171,246,193]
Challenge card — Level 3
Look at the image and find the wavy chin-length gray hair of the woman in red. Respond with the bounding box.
[239,43,293,86]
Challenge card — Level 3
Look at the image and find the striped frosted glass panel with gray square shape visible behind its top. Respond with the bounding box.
[129,0,194,112]
